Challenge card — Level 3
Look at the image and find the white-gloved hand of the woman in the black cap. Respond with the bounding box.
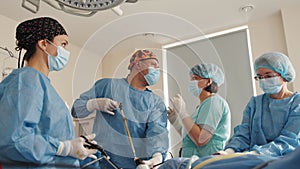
[56,134,97,160]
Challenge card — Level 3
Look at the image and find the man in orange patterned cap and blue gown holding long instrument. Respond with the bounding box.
[72,50,169,169]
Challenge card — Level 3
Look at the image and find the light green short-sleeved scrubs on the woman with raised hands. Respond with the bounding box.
[182,94,231,157]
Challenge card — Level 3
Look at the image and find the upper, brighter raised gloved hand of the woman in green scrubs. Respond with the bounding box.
[170,94,189,120]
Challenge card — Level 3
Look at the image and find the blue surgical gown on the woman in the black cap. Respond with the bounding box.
[0,67,79,168]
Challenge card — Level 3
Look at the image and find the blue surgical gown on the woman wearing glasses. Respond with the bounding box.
[225,92,300,157]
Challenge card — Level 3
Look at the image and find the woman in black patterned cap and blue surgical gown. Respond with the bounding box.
[0,17,96,168]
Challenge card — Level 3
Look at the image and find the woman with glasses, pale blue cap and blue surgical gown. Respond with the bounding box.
[219,52,300,157]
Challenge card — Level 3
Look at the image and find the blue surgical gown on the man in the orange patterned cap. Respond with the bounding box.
[72,78,169,169]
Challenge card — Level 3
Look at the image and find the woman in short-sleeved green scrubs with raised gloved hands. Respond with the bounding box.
[168,63,231,157]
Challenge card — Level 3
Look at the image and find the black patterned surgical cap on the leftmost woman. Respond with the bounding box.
[16,17,67,50]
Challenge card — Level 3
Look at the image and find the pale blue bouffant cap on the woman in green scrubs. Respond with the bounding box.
[190,63,224,86]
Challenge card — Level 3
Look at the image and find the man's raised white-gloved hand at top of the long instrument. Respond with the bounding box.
[86,98,120,115]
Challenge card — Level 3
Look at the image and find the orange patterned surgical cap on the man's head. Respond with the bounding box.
[128,49,158,70]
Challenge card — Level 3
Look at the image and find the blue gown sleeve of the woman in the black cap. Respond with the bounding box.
[1,72,59,163]
